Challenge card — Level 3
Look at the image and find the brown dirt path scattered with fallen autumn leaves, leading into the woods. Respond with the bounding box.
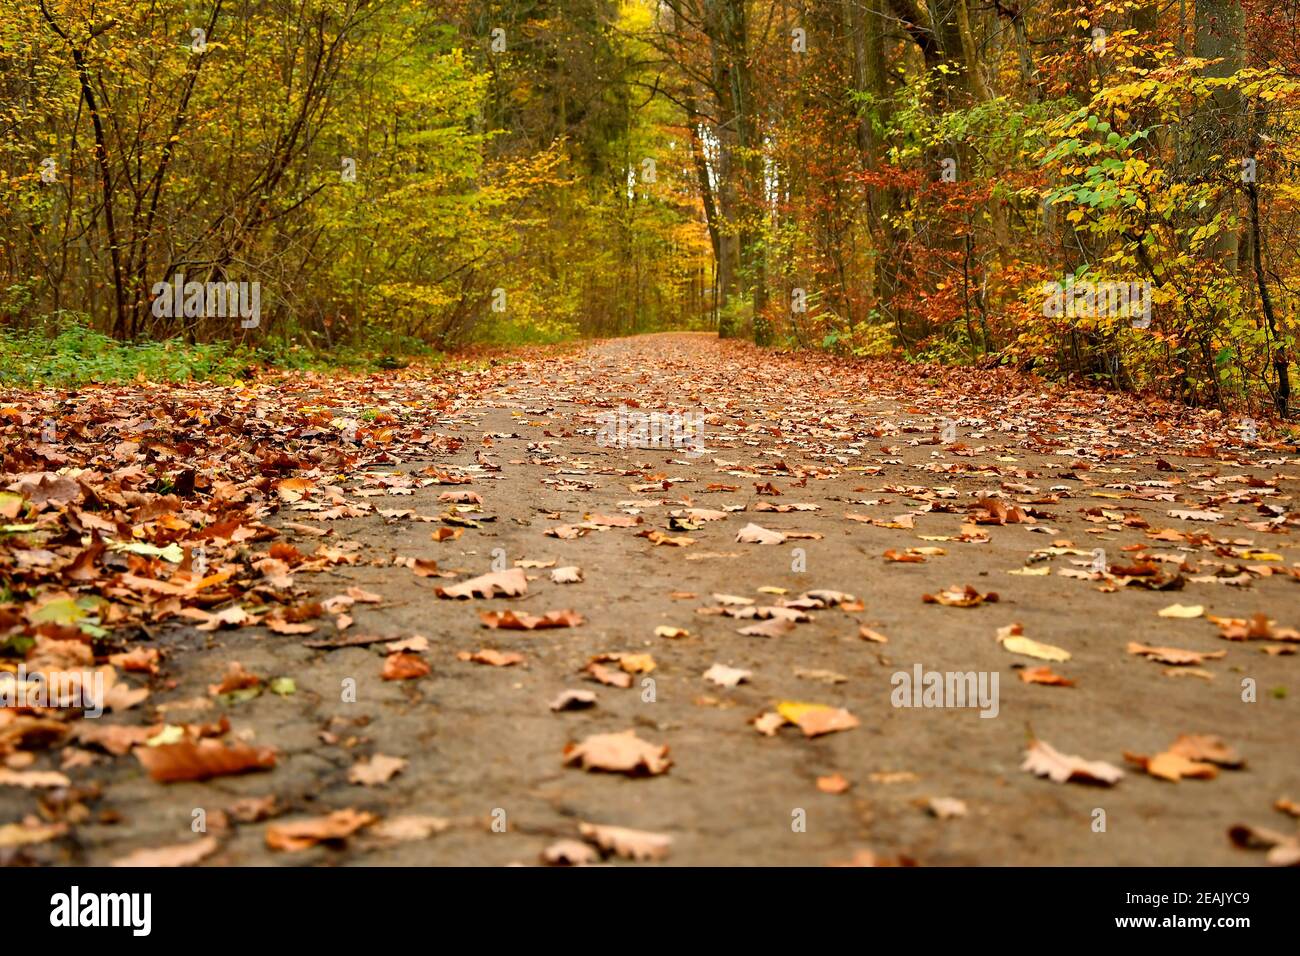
[0,336,1300,865]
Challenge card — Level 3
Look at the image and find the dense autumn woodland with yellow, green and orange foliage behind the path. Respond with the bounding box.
[0,0,1300,414]
